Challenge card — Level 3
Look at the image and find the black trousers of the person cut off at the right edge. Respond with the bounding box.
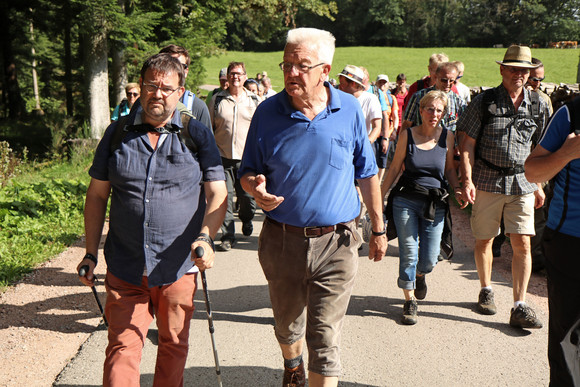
[544,227,580,387]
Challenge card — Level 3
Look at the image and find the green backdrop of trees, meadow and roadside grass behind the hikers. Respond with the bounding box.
[0,0,580,284]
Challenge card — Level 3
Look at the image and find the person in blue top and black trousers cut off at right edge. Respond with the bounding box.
[525,97,580,386]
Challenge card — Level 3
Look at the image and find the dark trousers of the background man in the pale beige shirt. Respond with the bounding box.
[221,157,256,241]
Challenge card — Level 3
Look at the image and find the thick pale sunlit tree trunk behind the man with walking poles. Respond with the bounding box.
[84,20,111,138]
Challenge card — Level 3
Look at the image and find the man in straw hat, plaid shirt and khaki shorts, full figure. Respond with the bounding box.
[457,45,549,329]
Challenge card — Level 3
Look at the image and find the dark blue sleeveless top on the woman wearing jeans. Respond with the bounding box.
[403,128,447,188]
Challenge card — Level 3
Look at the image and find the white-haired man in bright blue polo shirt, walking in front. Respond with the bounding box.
[239,28,387,387]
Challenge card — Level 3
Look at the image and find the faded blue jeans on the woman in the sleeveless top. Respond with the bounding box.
[393,196,445,290]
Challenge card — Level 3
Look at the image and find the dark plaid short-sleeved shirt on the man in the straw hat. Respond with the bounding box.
[457,85,549,195]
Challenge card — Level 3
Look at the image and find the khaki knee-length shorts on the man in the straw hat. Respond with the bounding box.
[471,190,536,239]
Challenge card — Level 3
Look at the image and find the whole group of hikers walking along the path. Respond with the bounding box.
[78,28,580,386]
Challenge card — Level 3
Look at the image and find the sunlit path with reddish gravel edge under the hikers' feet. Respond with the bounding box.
[0,209,548,386]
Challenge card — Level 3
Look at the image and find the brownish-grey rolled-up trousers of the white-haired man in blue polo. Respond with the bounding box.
[258,218,361,376]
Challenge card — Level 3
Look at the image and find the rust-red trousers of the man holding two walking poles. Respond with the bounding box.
[103,272,197,387]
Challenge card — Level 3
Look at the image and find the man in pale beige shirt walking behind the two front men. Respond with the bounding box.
[209,62,260,251]
